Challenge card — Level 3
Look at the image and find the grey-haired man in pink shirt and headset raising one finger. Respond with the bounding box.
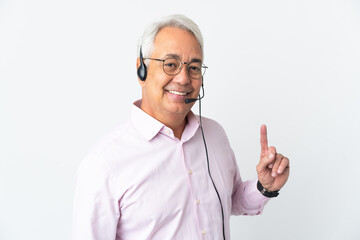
[73,15,289,240]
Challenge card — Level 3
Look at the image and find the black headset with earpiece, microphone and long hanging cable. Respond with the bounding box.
[137,46,225,240]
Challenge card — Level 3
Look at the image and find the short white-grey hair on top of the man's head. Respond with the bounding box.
[137,14,204,58]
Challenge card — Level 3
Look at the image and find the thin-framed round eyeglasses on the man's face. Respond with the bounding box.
[144,58,208,78]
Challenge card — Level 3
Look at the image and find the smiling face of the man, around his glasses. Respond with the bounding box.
[139,27,202,121]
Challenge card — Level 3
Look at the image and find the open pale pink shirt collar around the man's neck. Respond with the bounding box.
[131,100,199,142]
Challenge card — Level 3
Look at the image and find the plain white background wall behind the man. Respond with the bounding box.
[0,0,360,240]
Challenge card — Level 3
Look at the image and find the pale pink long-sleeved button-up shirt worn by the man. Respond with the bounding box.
[73,100,268,240]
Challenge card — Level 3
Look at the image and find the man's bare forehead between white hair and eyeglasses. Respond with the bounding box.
[152,27,202,61]
